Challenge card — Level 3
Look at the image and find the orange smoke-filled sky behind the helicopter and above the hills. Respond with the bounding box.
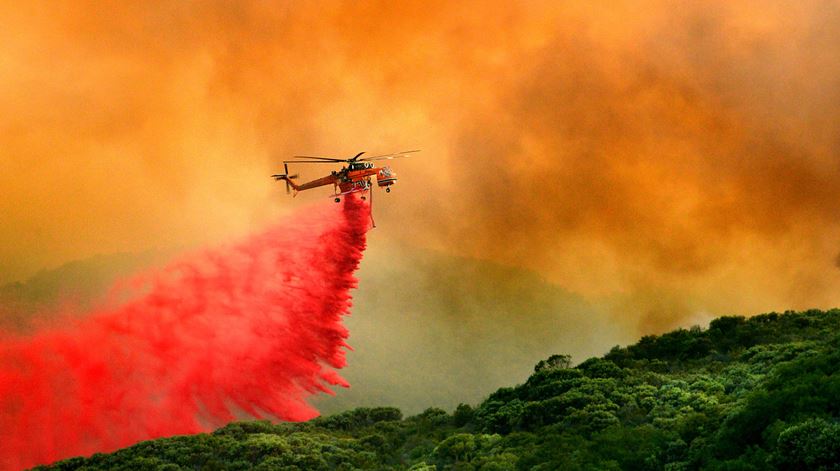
[0,0,840,338]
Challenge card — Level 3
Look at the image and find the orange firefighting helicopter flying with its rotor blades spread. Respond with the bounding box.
[272,150,420,203]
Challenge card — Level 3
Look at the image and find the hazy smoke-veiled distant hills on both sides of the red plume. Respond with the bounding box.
[0,244,630,413]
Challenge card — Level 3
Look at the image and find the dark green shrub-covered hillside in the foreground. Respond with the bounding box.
[36,310,840,470]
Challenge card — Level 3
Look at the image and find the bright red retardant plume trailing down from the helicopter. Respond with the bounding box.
[0,198,369,469]
